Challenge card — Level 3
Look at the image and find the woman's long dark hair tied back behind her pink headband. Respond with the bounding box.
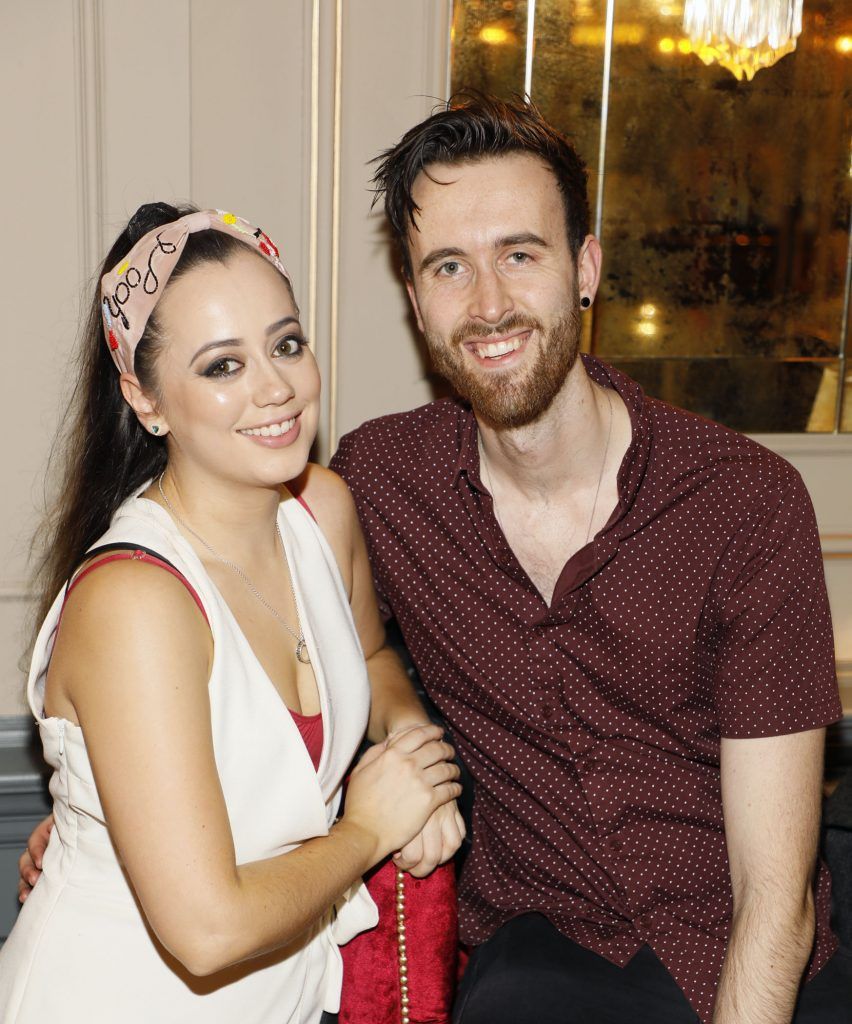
[34,203,246,629]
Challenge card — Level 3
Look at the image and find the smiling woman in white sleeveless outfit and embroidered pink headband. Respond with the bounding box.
[0,204,460,1024]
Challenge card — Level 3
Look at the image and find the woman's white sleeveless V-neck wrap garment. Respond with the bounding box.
[0,488,378,1024]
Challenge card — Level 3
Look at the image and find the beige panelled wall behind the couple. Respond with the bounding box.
[0,0,852,716]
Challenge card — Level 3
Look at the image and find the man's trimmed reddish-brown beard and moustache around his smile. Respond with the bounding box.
[425,305,582,429]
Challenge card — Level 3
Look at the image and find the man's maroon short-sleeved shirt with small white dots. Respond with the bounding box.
[333,357,842,1021]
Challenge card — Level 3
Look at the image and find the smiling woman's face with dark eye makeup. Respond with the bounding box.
[144,249,320,486]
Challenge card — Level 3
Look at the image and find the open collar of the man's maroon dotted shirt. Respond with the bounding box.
[453,353,651,514]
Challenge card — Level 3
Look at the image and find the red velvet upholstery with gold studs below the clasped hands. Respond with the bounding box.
[338,860,459,1024]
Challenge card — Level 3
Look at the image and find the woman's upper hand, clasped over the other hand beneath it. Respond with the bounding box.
[342,725,462,862]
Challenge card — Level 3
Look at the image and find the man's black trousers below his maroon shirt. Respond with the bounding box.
[453,913,852,1024]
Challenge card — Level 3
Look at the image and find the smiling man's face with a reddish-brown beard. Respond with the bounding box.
[409,154,588,428]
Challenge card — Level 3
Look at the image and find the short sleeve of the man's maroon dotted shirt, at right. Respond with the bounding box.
[714,468,843,738]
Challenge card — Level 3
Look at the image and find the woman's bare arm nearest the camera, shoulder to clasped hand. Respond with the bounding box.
[48,562,459,974]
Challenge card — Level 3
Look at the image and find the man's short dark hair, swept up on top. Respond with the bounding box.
[373,91,589,279]
